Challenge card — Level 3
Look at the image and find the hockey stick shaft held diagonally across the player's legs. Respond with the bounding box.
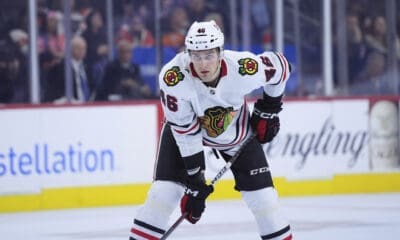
[160,133,257,240]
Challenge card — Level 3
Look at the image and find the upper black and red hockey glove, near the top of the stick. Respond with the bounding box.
[250,93,282,144]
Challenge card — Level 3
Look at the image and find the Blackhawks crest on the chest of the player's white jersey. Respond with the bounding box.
[200,107,236,137]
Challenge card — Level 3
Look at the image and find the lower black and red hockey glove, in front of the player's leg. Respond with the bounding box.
[181,171,214,224]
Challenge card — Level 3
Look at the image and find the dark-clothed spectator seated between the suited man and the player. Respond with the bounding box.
[96,41,151,101]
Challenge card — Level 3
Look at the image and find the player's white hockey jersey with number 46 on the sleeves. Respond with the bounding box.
[159,50,290,157]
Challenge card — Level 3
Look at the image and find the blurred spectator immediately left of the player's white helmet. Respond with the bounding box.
[162,7,189,50]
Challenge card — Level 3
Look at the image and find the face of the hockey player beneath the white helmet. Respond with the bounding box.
[190,48,221,82]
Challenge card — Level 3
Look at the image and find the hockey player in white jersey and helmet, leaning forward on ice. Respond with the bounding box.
[130,21,292,240]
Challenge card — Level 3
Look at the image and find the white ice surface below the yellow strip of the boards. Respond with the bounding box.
[0,193,400,240]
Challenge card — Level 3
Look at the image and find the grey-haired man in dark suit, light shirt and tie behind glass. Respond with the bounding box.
[44,36,94,103]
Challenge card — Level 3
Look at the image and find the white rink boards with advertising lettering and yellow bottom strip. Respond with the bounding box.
[0,97,400,212]
